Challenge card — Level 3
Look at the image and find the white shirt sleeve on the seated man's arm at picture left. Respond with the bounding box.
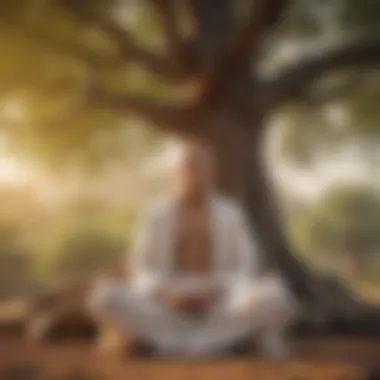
[129,206,161,294]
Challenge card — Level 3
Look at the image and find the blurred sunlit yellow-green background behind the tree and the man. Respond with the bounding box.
[0,0,380,298]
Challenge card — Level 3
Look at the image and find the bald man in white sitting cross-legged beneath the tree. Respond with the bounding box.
[91,142,295,356]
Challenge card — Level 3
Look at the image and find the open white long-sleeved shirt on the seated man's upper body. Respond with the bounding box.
[130,194,259,293]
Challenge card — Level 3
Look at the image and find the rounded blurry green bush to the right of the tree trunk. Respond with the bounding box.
[291,185,380,278]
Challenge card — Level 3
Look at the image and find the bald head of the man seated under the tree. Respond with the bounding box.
[175,141,216,195]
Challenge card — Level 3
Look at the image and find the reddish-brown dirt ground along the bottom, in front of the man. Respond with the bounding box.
[0,337,380,380]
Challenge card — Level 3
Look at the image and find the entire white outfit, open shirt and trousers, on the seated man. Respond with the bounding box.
[90,195,296,355]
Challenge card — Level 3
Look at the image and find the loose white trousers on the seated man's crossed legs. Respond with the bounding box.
[90,277,296,356]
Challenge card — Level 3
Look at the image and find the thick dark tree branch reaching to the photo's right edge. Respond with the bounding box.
[264,36,380,107]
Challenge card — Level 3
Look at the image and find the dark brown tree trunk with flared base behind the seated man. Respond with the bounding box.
[206,119,380,334]
